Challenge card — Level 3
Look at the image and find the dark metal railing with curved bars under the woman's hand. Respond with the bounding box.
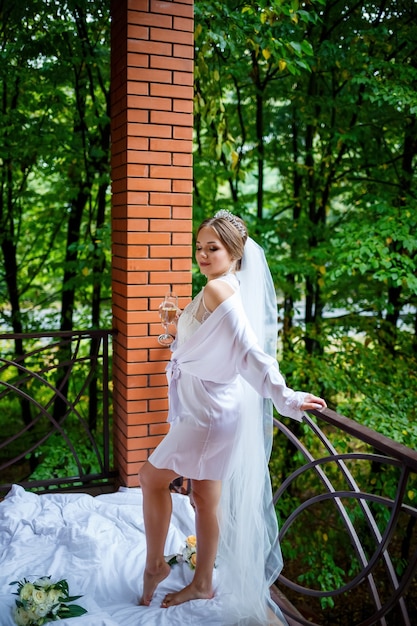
[274,409,417,626]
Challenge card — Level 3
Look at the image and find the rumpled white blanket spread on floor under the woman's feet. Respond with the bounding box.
[0,486,221,626]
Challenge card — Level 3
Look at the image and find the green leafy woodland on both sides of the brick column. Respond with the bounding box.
[0,0,417,616]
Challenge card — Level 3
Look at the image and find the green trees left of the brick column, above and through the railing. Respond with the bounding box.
[0,0,111,492]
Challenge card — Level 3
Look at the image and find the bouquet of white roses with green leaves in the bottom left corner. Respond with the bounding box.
[10,576,87,626]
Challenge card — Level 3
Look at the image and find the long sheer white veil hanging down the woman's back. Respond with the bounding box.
[214,238,285,626]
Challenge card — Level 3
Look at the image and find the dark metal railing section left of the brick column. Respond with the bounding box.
[0,330,116,497]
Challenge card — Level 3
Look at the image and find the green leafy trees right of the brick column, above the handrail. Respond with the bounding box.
[194,1,417,447]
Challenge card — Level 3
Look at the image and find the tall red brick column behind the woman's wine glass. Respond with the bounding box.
[111,0,194,486]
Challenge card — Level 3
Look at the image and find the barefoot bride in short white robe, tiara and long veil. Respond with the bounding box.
[140,211,326,626]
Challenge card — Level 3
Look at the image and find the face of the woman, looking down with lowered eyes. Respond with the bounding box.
[195,227,233,280]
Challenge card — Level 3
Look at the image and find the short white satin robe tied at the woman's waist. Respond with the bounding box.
[149,291,304,480]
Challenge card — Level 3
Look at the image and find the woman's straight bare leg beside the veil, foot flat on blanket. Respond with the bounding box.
[162,480,221,607]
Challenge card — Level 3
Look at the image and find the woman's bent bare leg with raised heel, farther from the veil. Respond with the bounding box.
[139,462,178,606]
